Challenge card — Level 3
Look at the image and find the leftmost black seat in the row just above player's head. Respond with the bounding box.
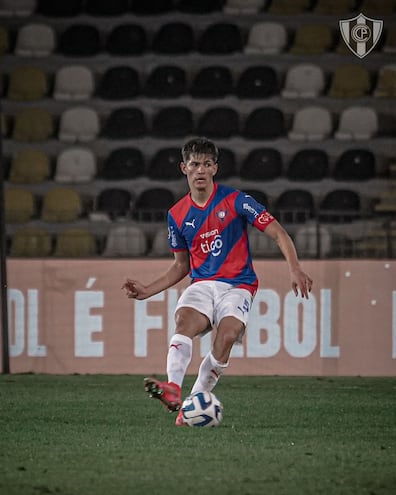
[102,107,147,139]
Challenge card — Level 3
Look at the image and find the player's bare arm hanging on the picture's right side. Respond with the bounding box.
[264,220,312,299]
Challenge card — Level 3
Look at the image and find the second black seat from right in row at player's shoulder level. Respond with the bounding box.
[275,189,314,223]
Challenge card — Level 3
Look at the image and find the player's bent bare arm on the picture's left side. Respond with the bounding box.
[121,250,190,300]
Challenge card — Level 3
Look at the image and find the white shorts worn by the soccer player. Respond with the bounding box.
[175,280,253,327]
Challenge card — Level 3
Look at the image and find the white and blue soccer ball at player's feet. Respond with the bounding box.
[181,392,223,426]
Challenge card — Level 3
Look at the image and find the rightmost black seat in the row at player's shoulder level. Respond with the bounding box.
[319,189,361,223]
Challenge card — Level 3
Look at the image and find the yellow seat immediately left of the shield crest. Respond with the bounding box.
[289,24,333,55]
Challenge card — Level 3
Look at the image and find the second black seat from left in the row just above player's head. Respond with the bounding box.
[152,106,193,138]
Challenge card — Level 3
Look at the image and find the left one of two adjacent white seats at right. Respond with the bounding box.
[288,106,332,141]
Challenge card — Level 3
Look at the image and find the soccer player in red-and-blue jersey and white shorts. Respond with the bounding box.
[122,137,312,426]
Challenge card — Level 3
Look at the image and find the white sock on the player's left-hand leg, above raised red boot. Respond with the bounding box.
[166,333,192,387]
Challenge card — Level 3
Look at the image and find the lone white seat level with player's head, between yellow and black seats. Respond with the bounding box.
[54,148,96,183]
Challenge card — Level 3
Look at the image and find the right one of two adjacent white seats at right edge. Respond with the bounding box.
[334,106,378,140]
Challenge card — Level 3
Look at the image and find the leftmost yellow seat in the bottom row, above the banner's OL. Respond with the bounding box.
[10,227,52,258]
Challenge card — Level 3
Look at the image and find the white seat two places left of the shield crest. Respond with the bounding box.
[244,22,287,54]
